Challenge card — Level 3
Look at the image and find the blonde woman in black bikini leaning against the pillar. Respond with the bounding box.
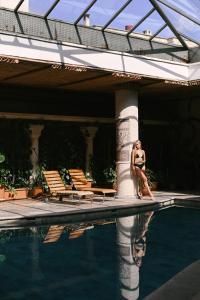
[131,140,154,200]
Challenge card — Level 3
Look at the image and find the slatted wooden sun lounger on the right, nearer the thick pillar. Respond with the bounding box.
[68,169,116,199]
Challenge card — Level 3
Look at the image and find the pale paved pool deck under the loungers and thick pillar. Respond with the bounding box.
[0,191,200,228]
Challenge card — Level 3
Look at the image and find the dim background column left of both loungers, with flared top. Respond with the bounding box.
[30,124,44,178]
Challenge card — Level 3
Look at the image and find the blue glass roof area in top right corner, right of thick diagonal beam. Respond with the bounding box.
[156,3,200,46]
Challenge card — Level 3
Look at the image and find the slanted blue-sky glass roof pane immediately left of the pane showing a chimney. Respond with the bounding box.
[49,0,92,23]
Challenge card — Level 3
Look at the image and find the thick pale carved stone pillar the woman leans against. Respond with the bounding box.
[116,90,138,198]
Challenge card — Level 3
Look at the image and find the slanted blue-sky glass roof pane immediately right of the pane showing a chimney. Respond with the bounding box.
[109,0,152,30]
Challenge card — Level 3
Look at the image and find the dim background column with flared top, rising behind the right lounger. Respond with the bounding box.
[81,126,98,177]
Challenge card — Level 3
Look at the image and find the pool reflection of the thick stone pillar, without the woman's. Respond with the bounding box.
[117,216,139,300]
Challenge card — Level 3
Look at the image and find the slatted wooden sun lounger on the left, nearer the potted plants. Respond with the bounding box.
[43,171,94,201]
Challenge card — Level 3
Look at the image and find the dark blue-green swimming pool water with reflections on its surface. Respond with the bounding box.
[0,208,200,300]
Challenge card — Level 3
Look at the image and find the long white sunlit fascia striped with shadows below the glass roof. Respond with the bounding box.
[0,34,191,80]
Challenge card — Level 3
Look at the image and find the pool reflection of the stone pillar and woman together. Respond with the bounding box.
[117,212,153,300]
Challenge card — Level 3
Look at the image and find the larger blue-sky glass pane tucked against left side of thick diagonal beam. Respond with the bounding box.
[135,12,165,35]
